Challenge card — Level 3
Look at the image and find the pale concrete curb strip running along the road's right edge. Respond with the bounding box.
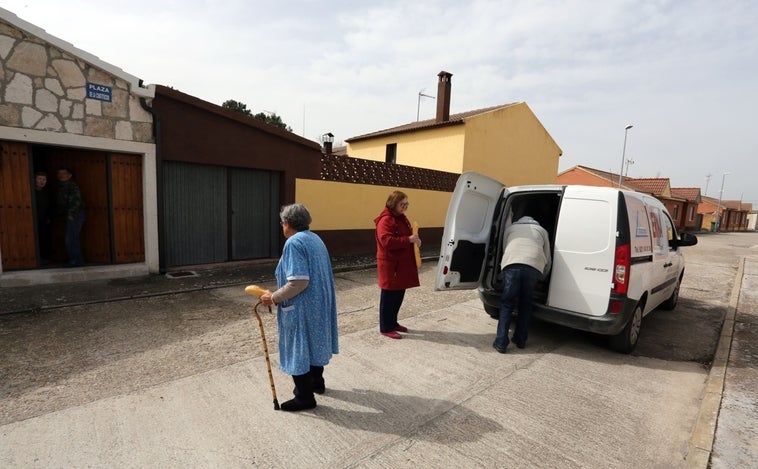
[686,258,745,469]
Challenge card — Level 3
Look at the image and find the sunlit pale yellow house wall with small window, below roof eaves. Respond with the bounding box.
[347,125,465,173]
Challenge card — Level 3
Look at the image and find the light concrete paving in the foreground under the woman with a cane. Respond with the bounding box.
[0,298,705,468]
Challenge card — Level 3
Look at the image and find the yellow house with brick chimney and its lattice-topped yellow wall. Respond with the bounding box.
[296,72,561,252]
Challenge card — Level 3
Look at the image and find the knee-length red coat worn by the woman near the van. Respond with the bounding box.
[374,207,419,290]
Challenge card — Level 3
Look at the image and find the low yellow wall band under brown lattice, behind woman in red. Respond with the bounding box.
[295,179,452,231]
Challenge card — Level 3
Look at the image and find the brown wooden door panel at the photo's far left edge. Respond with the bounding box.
[0,142,37,270]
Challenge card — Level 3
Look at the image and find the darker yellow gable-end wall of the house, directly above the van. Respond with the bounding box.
[463,103,561,186]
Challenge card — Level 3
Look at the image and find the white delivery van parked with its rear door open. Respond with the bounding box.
[435,172,697,353]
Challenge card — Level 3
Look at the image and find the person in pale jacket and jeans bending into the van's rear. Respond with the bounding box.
[492,216,551,353]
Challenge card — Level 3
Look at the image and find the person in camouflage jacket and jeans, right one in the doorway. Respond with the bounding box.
[56,168,84,267]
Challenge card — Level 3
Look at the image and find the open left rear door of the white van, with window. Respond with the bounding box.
[434,172,507,290]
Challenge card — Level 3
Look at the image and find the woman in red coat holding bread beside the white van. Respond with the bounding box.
[374,191,421,339]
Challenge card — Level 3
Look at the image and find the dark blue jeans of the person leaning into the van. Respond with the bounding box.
[495,264,541,348]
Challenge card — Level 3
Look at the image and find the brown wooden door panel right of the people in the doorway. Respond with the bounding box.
[110,154,145,263]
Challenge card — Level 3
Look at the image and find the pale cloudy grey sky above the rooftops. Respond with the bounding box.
[3,0,758,206]
